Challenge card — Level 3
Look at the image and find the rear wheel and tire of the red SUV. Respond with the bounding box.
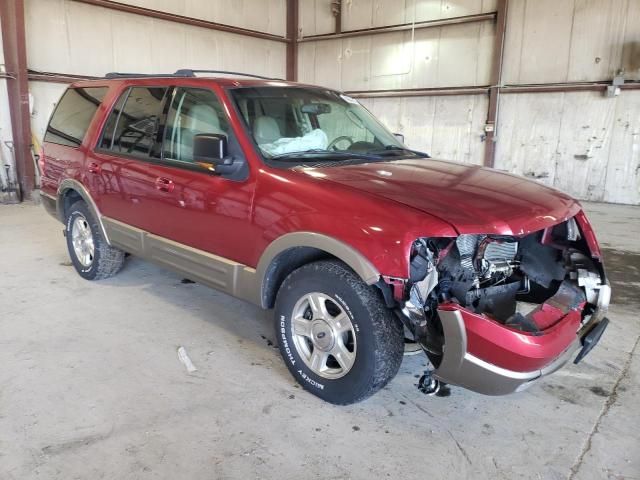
[65,200,124,280]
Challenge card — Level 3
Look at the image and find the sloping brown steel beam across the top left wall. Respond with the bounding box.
[73,0,287,42]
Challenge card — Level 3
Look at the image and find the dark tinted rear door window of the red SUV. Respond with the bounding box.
[100,87,167,157]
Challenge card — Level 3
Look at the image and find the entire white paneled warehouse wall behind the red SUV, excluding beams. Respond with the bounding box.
[0,0,640,204]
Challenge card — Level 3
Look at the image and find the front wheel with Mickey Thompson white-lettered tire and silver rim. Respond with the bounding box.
[275,261,404,405]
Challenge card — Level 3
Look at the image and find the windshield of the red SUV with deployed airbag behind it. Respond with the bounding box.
[230,87,417,161]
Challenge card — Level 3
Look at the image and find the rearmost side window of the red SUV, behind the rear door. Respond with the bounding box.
[44,87,108,147]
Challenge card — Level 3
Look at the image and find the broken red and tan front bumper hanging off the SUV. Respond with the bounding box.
[433,285,611,395]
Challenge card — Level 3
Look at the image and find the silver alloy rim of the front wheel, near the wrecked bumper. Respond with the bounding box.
[291,292,357,380]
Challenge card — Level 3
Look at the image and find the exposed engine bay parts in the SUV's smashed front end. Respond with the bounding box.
[402,218,603,361]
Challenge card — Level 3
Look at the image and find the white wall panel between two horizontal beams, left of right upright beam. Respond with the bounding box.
[298,22,494,90]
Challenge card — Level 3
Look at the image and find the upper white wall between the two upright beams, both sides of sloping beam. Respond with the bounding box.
[298,0,495,90]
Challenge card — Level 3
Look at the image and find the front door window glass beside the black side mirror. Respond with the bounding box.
[164,88,231,162]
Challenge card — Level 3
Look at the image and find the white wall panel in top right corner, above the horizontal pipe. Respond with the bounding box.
[503,0,640,84]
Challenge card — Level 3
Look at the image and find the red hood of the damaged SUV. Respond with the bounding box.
[302,159,580,235]
